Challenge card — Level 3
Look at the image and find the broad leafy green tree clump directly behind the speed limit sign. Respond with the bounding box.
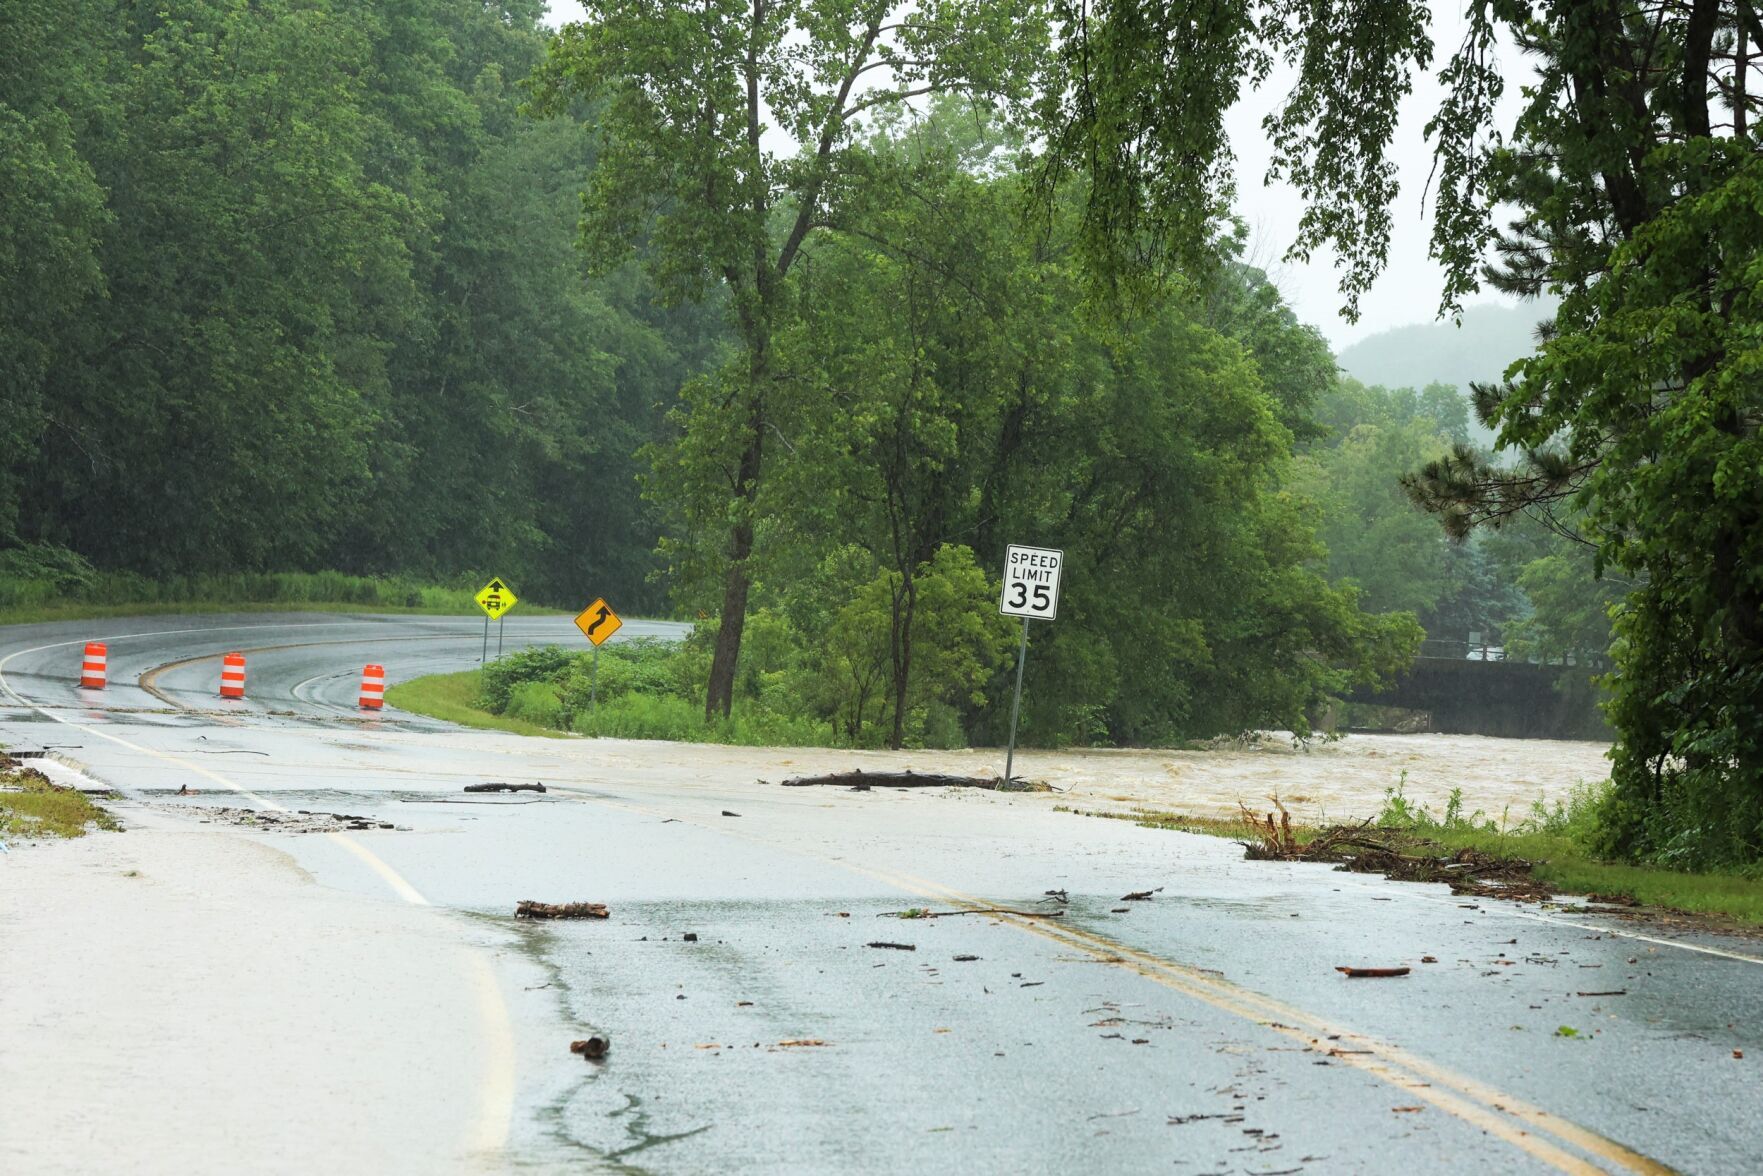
[760,108,1439,742]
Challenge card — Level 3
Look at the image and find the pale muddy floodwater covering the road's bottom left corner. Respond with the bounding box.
[0,829,501,1172]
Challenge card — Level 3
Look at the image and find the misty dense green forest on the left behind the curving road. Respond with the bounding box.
[0,0,723,608]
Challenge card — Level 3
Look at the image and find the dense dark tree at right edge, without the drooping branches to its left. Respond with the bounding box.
[1412,0,1763,864]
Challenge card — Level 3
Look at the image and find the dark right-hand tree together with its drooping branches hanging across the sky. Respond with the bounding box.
[1045,0,1763,862]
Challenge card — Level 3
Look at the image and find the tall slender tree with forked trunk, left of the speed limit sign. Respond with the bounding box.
[536,0,1044,716]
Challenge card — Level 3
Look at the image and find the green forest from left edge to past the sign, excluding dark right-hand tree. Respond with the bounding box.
[0,0,1600,746]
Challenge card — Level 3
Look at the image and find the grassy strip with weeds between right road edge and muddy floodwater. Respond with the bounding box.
[1065,785,1763,926]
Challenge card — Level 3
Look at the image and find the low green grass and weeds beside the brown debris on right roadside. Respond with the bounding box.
[1063,781,1763,926]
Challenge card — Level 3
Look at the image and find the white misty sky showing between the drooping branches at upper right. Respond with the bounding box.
[550,0,1516,351]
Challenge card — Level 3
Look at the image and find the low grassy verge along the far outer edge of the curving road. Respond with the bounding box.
[0,568,561,624]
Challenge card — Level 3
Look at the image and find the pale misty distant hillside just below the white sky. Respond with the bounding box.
[1336,301,1551,391]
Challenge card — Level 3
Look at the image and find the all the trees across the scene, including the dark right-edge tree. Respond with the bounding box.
[17,0,1763,860]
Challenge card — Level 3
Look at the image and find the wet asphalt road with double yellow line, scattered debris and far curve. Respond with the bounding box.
[0,615,1763,1174]
